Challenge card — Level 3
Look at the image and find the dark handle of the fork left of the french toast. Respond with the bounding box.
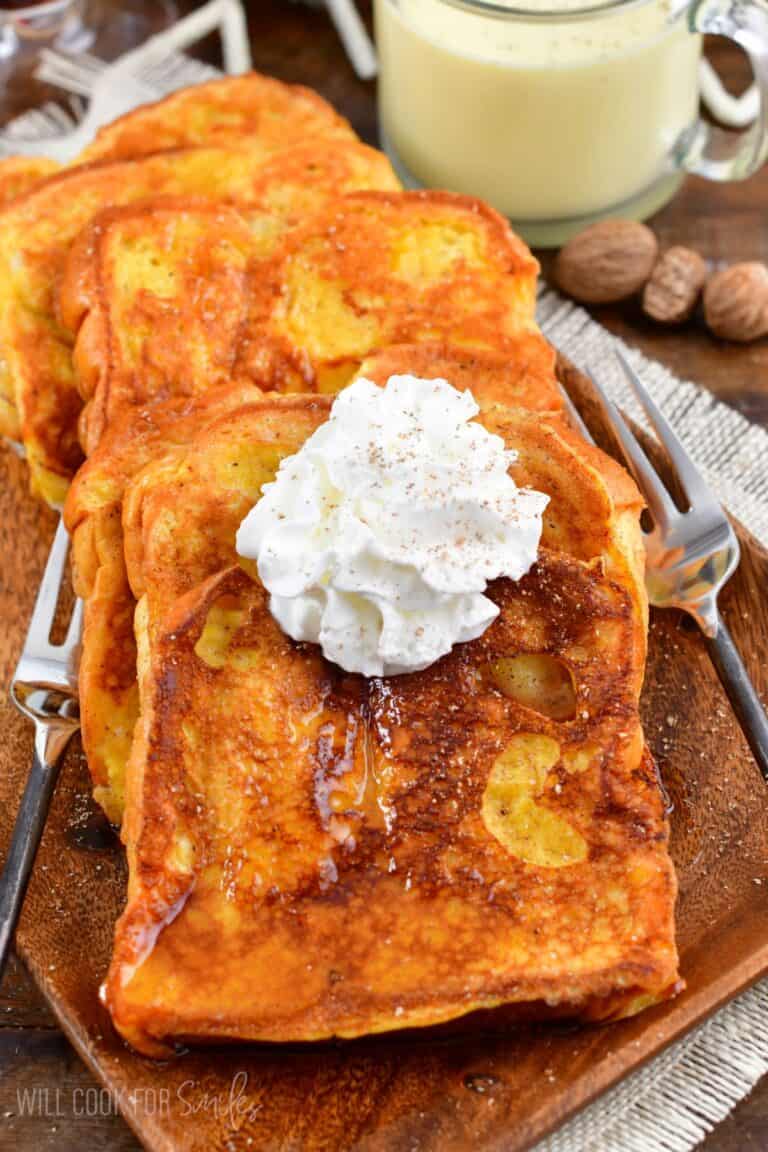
[0,721,74,982]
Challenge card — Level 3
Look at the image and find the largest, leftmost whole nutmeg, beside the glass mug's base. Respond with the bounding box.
[555,220,659,304]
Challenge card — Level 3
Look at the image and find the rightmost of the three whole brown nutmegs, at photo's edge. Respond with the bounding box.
[704,262,768,343]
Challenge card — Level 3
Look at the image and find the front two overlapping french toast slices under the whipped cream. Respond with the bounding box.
[106,396,677,1055]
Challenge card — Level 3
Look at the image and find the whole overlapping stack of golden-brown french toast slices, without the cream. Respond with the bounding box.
[0,74,678,1054]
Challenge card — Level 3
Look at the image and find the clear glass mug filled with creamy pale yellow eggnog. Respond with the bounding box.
[374,0,768,245]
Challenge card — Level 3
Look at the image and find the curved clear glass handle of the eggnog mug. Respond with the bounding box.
[674,0,768,180]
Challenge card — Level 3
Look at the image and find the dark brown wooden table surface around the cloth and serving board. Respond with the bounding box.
[0,0,768,1152]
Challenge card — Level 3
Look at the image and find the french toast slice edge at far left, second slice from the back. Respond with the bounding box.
[0,136,398,503]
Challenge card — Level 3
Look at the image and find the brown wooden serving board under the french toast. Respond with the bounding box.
[0,366,768,1152]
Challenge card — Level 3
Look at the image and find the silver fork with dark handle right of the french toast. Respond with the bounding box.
[582,350,768,780]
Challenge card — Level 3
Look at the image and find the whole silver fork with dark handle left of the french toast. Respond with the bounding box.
[0,520,83,979]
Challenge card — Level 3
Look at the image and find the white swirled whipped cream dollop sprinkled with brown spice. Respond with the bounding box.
[237,376,547,676]
